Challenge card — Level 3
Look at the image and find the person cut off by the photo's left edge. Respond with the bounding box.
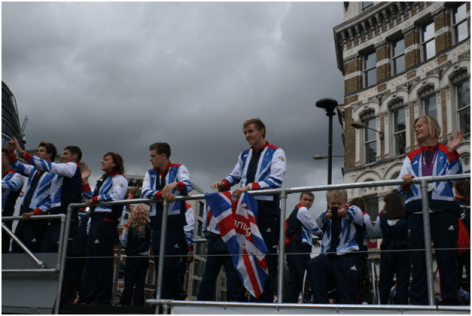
[2,148,25,253]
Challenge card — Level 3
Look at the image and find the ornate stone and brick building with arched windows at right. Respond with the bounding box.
[334,2,470,220]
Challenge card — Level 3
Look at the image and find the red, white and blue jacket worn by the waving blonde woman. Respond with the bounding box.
[398,143,463,212]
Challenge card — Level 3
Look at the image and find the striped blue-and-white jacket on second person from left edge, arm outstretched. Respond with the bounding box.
[10,157,57,213]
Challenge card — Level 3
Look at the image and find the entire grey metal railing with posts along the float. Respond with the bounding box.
[2,174,470,313]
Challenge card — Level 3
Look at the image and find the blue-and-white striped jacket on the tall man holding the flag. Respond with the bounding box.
[223,141,286,201]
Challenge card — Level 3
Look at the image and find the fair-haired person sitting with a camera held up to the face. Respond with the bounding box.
[307,190,365,304]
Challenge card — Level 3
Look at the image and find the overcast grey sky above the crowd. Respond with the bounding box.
[2,2,344,215]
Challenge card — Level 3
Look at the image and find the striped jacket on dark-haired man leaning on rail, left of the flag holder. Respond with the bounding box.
[141,163,193,216]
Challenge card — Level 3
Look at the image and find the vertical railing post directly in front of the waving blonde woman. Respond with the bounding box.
[420,179,435,306]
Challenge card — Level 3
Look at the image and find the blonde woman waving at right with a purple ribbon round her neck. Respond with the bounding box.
[398,116,464,305]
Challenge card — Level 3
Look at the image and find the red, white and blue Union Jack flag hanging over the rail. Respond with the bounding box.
[205,191,269,297]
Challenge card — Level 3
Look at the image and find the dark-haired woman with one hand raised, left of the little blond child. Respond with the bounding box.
[80,152,128,305]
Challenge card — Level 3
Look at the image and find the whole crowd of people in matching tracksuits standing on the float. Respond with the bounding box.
[2,116,470,305]
